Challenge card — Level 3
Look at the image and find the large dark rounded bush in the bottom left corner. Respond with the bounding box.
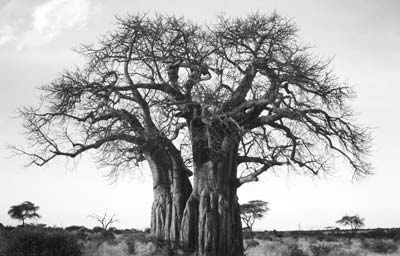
[0,227,83,256]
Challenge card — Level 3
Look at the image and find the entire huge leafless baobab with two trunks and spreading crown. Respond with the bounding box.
[17,13,370,255]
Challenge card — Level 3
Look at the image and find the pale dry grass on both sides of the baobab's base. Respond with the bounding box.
[85,234,400,256]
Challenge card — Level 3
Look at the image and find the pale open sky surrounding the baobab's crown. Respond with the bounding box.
[0,0,400,230]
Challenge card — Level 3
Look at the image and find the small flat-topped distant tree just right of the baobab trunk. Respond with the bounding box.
[240,200,269,240]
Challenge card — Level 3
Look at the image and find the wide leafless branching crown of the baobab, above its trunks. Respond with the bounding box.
[18,13,370,181]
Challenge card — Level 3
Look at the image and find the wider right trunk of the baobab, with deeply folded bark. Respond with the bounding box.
[181,125,243,256]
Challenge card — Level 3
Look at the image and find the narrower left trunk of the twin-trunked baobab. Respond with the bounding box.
[145,145,192,243]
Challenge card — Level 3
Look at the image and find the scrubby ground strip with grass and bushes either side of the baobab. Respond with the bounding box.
[0,226,400,256]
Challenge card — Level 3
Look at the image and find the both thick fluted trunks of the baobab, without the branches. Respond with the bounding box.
[145,123,243,256]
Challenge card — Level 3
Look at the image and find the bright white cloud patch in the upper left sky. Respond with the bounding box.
[17,0,92,49]
